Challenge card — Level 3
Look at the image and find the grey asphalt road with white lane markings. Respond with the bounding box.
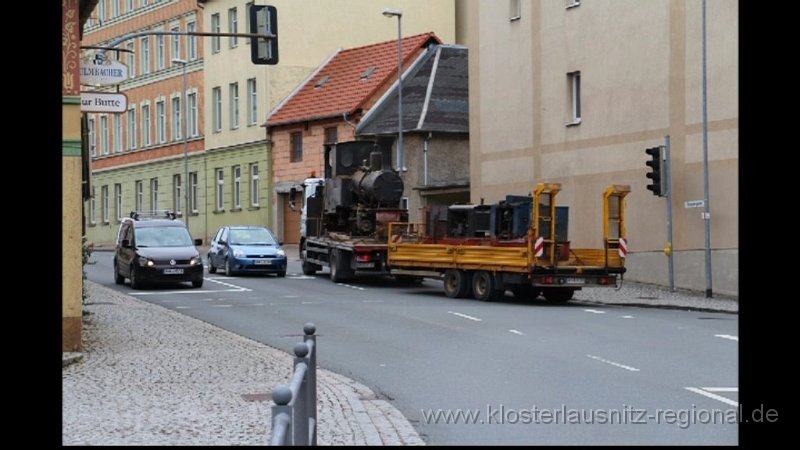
[87,252,738,445]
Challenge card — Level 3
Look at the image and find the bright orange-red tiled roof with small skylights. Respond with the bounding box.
[266,32,442,127]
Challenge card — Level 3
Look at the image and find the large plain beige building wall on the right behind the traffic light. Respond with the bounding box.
[457,0,739,295]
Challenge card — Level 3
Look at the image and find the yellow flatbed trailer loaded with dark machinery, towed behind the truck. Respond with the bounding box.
[388,183,630,303]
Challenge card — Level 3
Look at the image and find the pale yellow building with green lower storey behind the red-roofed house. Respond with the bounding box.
[201,0,456,243]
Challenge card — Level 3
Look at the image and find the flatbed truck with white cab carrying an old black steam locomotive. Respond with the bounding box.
[289,139,408,283]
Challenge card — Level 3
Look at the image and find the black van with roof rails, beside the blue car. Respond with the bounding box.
[114,213,203,289]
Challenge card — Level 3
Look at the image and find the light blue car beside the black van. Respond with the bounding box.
[208,225,286,277]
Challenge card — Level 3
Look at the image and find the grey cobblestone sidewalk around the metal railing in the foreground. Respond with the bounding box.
[62,282,424,445]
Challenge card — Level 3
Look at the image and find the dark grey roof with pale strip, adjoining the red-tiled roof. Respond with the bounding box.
[356,45,469,136]
